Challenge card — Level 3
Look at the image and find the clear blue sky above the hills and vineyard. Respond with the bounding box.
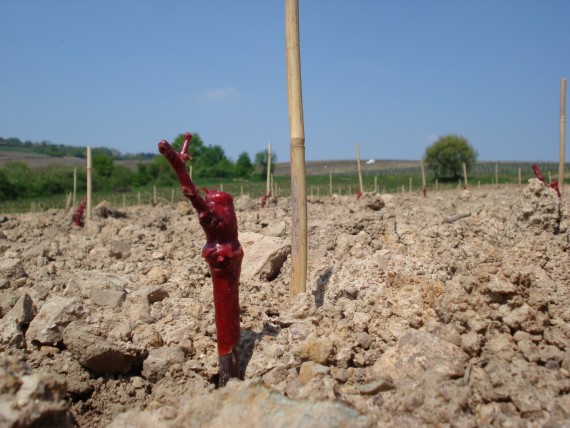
[0,0,570,161]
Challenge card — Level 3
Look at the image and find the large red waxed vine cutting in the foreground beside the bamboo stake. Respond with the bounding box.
[158,133,243,387]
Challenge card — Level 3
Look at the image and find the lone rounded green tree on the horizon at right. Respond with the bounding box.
[424,135,477,179]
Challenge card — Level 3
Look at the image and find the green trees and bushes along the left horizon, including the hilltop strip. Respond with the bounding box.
[0,134,276,200]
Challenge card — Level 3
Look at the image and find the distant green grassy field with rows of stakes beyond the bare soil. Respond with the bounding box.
[0,151,570,214]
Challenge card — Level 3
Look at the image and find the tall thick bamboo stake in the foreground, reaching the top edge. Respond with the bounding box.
[285,0,307,301]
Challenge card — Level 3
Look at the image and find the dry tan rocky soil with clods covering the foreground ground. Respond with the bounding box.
[0,179,570,428]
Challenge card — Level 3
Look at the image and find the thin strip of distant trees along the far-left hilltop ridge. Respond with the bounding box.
[0,137,156,160]
